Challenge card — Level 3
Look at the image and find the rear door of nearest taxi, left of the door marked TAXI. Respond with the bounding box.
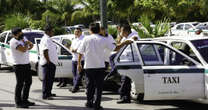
[114,43,144,93]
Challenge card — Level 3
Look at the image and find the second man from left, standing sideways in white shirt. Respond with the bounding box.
[40,26,58,100]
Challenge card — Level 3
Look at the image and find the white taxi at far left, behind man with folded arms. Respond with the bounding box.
[0,29,44,71]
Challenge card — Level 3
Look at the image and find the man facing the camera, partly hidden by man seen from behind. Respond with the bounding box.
[71,28,84,93]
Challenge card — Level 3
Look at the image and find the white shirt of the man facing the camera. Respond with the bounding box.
[71,35,84,61]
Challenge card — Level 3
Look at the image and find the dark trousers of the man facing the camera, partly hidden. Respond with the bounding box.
[72,61,84,89]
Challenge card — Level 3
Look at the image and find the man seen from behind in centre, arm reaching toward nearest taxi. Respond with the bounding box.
[77,23,132,110]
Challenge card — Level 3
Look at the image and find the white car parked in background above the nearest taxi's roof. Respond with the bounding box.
[171,22,199,36]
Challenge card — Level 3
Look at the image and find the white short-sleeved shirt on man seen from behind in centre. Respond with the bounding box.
[77,34,116,69]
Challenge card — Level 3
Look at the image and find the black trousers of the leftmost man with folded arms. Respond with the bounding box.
[14,64,32,104]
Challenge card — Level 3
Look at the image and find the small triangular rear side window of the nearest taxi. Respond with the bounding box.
[118,45,140,63]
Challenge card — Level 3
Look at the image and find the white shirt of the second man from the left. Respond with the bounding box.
[39,34,58,65]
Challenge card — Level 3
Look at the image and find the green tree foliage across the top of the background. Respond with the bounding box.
[0,0,208,33]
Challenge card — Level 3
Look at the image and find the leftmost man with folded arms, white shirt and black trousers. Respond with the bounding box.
[10,27,35,108]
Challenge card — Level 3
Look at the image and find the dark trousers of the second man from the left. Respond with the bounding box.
[42,63,56,97]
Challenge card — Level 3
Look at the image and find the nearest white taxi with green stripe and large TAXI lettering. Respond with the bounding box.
[114,37,208,101]
